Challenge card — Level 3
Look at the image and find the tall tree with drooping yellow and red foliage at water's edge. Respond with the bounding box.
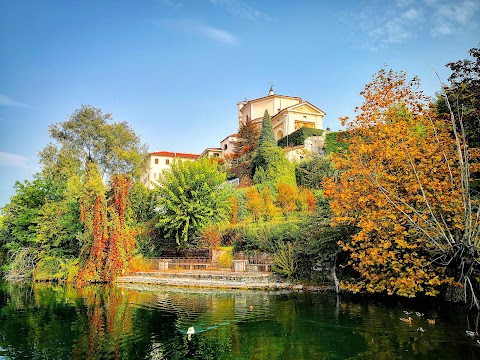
[40,105,146,284]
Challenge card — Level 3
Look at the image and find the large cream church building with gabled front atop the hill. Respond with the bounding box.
[237,88,325,140]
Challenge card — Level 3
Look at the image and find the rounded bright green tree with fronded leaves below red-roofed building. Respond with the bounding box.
[155,158,231,246]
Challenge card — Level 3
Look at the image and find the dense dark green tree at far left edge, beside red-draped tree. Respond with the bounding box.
[0,174,82,277]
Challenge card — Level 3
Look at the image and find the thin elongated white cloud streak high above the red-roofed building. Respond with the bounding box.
[155,19,238,45]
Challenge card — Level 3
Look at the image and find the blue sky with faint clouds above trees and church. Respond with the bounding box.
[0,0,480,206]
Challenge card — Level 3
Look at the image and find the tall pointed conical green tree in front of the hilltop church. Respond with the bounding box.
[250,111,296,190]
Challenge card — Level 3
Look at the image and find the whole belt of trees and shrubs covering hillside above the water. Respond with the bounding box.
[0,49,480,307]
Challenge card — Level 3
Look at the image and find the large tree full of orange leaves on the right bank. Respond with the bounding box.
[324,69,478,297]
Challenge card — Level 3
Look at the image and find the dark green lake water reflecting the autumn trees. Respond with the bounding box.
[0,283,480,360]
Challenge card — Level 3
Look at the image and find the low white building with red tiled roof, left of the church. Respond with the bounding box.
[142,151,198,189]
